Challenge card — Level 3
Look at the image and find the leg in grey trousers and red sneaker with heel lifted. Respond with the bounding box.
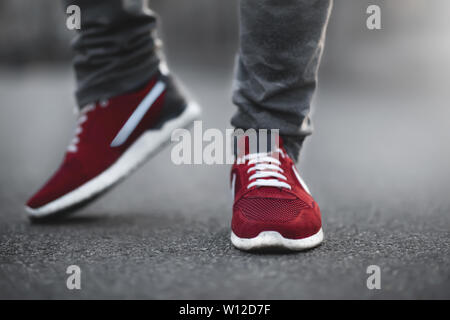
[26,0,199,219]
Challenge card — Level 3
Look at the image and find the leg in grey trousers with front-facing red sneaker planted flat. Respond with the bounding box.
[231,0,331,250]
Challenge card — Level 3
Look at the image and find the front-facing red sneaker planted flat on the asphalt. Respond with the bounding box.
[231,138,323,250]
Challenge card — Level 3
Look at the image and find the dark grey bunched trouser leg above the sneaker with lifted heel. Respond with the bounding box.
[63,0,159,106]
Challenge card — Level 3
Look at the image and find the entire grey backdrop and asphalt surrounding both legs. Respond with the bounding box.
[0,0,450,299]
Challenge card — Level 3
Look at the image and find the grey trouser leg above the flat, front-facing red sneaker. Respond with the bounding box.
[231,0,331,159]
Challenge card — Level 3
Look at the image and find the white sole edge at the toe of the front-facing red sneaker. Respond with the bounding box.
[231,228,323,251]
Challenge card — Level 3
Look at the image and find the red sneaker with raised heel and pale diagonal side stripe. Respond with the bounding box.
[26,75,200,217]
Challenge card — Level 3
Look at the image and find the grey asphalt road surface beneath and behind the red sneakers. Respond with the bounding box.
[0,58,450,299]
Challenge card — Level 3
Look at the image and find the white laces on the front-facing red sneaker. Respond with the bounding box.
[241,149,292,190]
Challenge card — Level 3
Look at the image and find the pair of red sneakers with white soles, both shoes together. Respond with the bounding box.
[26,74,323,250]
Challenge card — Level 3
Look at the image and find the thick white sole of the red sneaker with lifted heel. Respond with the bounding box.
[25,102,201,218]
